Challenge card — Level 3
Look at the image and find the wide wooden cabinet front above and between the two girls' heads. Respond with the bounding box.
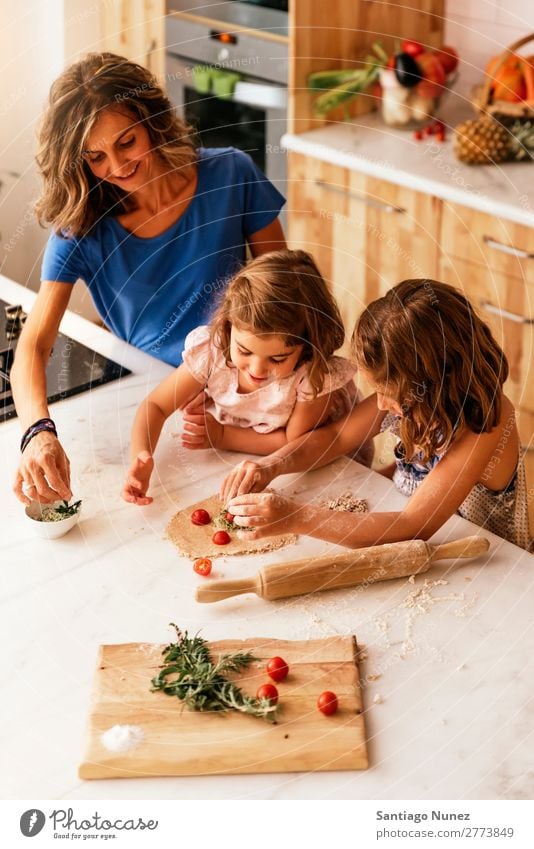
[288,153,440,352]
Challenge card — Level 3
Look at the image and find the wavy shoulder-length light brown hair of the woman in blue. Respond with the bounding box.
[35,53,197,236]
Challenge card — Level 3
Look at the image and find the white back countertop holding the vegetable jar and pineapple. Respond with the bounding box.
[281,99,534,227]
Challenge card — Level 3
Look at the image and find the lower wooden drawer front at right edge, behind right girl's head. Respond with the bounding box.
[441,256,534,418]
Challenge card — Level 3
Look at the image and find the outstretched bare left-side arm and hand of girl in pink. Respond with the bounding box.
[122,365,203,506]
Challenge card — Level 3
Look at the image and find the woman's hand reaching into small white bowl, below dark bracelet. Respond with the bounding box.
[13,431,72,504]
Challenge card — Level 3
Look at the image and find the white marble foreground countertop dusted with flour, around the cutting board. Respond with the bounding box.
[0,279,534,800]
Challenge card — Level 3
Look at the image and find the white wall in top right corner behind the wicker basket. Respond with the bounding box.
[445,0,534,95]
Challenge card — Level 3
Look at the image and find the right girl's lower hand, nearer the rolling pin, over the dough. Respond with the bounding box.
[226,492,296,539]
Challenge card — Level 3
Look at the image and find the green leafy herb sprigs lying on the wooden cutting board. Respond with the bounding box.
[151,622,276,721]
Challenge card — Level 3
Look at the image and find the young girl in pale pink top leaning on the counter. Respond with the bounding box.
[122,250,362,505]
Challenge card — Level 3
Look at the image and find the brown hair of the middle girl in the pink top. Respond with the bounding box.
[211,250,345,397]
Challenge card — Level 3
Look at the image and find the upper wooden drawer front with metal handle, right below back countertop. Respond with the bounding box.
[441,203,534,283]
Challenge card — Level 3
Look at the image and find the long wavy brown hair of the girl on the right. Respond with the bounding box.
[352,280,508,461]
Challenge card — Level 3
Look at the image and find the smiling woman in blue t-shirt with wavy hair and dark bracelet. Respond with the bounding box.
[11,53,285,504]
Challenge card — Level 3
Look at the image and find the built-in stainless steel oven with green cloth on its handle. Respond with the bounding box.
[166,0,288,202]
